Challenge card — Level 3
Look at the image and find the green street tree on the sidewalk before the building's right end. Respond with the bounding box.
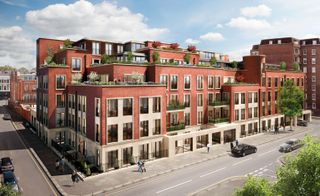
[279,80,304,130]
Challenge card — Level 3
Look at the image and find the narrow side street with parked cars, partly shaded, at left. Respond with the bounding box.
[0,100,57,196]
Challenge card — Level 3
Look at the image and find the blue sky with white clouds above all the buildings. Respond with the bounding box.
[0,0,320,68]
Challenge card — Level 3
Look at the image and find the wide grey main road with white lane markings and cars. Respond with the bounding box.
[109,120,320,196]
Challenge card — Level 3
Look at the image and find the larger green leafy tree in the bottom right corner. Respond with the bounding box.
[274,136,320,196]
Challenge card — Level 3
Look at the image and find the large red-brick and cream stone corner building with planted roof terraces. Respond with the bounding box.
[32,38,310,171]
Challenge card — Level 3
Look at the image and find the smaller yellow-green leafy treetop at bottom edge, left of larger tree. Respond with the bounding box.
[235,176,272,196]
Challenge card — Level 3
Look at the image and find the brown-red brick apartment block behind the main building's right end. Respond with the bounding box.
[251,38,320,116]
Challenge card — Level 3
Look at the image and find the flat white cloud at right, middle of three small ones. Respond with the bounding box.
[227,17,271,30]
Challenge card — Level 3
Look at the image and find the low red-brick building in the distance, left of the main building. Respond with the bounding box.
[10,71,37,105]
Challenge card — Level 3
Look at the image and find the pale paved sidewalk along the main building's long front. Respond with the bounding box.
[53,127,309,195]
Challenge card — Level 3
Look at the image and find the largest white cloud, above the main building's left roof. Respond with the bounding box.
[26,0,168,41]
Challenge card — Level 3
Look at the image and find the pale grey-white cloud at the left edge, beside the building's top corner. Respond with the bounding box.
[0,26,35,67]
